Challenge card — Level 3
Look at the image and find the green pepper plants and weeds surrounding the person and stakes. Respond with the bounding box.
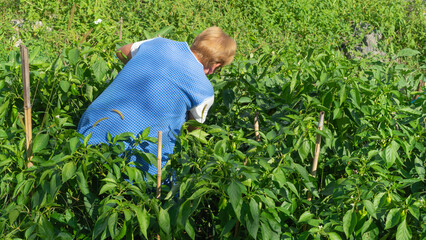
[0,0,426,239]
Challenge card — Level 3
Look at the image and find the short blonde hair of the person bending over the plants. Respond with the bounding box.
[191,27,237,68]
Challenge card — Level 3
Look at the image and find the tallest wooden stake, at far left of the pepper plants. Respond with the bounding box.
[21,45,33,167]
